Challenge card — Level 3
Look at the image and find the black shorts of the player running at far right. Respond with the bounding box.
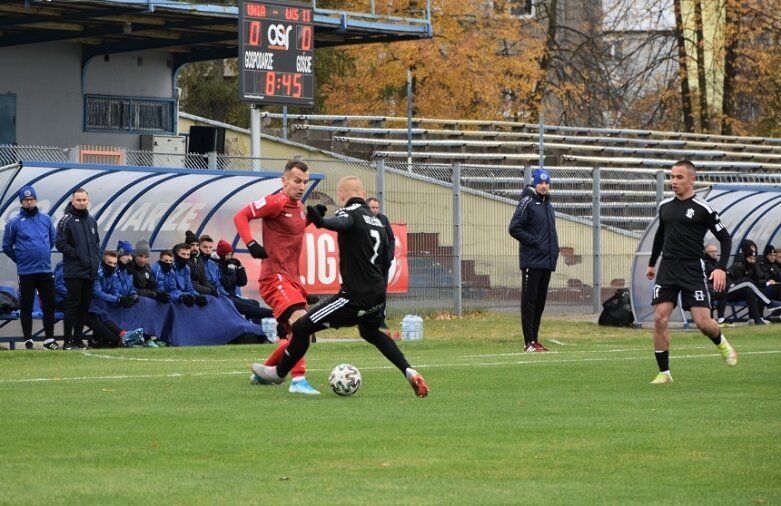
[651,257,711,309]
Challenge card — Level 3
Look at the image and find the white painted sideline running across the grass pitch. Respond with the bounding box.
[0,347,781,384]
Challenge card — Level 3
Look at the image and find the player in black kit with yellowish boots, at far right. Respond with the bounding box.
[646,160,738,385]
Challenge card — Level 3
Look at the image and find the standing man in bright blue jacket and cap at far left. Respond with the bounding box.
[3,186,59,350]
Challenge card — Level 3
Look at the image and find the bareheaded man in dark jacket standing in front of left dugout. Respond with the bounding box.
[54,188,100,350]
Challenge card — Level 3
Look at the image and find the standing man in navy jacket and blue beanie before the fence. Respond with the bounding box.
[509,169,559,353]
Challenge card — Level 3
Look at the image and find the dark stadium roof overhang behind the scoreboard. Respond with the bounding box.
[0,0,432,67]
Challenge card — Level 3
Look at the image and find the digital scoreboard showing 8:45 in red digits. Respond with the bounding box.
[239,0,315,106]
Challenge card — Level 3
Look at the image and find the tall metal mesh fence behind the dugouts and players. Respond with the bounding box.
[0,146,781,316]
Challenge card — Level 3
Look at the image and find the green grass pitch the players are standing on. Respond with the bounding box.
[0,314,781,506]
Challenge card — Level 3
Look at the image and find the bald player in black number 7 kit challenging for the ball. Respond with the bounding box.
[252,176,428,397]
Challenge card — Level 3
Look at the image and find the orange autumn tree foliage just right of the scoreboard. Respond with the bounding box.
[320,0,544,120]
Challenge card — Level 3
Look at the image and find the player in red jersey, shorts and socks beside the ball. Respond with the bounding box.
[233,160,325,395]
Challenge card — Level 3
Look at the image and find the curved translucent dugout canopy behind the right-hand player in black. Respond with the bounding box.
[631,184,781,325]
